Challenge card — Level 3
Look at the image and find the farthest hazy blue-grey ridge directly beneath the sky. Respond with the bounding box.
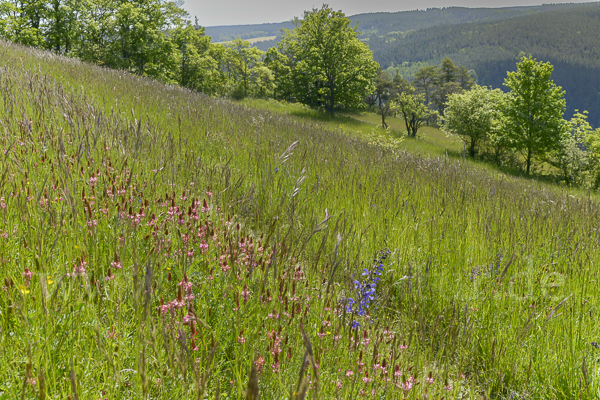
[206,4,573,42]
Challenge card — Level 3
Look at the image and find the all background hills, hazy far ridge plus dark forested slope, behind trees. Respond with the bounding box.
[206,2,600,127]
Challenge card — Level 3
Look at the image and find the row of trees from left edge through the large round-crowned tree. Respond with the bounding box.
[0,0,379,106]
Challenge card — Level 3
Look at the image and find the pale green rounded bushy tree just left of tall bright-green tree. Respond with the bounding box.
[443,85,503,157]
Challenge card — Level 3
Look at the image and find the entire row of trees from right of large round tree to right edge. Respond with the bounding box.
[378,56,600,190]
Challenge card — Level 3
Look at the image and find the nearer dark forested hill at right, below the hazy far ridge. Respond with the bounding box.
[369,3,600,126]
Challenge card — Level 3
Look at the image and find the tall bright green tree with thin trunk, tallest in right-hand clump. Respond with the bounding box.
[502,56,568,174]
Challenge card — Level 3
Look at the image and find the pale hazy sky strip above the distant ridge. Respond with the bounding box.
[183,0,589,26]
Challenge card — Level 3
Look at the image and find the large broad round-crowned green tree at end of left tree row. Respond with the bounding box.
[280,5,379,114]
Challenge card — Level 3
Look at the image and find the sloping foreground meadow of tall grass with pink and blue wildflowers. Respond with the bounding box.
[0,39,600,400]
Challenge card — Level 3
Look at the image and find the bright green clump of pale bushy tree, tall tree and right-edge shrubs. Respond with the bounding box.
[442,56,600,186]
